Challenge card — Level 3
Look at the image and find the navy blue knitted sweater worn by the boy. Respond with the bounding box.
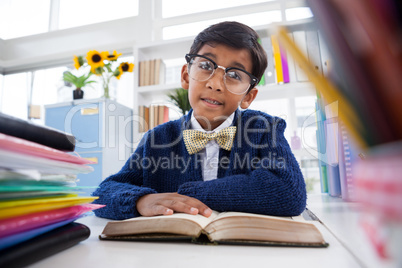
[93,110,306,220]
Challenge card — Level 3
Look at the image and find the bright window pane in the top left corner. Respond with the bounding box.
[0,0,50,39]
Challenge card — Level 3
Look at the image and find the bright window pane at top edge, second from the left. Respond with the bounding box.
[59,0,138,29]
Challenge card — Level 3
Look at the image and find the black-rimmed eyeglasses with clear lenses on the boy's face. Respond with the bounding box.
[186,54,258,95]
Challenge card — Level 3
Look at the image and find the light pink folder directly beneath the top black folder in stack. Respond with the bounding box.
[0,133,94,164]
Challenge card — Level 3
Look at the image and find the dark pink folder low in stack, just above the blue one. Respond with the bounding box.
[0,204,104,238]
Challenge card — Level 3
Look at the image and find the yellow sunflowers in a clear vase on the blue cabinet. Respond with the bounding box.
[73,50,134,98]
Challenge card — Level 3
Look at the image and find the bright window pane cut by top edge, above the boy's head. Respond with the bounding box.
[161,0,274,18]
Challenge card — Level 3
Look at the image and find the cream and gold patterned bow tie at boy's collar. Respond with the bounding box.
[183,126,236,154]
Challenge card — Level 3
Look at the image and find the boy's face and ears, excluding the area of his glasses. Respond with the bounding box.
[181,44,258,130]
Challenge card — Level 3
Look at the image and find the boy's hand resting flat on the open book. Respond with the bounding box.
[137,193,212,217]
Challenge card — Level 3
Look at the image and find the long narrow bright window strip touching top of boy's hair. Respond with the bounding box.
[163,10,282,39]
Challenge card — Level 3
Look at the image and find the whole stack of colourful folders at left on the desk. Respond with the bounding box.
[0,113,102,267]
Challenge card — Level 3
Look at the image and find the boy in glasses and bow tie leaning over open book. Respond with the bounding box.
[93,22,306,220]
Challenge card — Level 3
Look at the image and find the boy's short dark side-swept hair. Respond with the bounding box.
[190,21,268,80]
